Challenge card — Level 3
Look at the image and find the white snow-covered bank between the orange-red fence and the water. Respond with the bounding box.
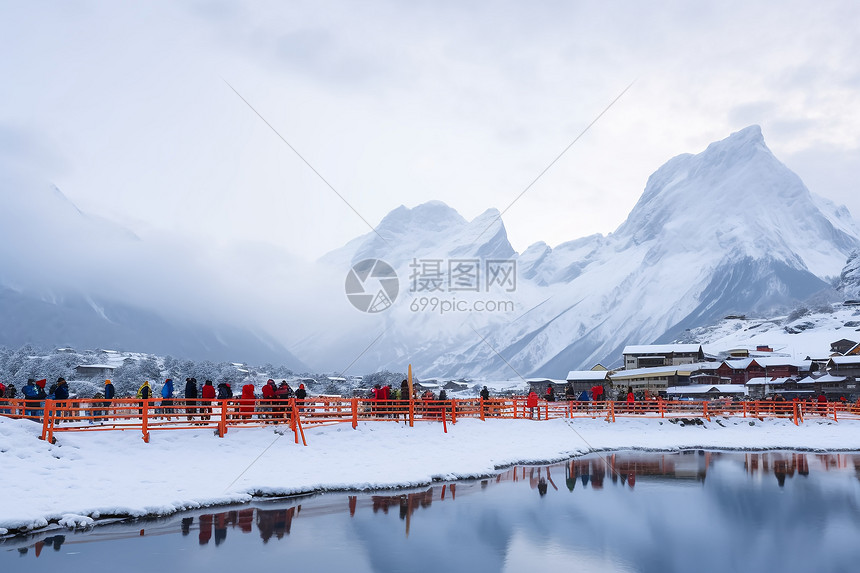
[0,418,860,533]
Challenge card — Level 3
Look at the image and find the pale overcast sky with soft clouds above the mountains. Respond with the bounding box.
[0,0,860,259]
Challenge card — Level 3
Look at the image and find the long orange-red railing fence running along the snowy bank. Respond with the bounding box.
[0,397,860,445]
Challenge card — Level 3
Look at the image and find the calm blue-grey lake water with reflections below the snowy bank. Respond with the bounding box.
[0,451,860,573]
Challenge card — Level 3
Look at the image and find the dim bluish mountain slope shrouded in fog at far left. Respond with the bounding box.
[0,146,305,369]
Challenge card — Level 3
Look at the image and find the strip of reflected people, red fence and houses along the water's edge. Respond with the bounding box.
[3,451,860,557]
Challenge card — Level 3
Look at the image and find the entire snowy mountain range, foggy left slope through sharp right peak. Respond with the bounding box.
[0,126,860,378]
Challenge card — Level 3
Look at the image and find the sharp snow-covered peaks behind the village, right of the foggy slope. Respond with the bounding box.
[310,126,860,377]
